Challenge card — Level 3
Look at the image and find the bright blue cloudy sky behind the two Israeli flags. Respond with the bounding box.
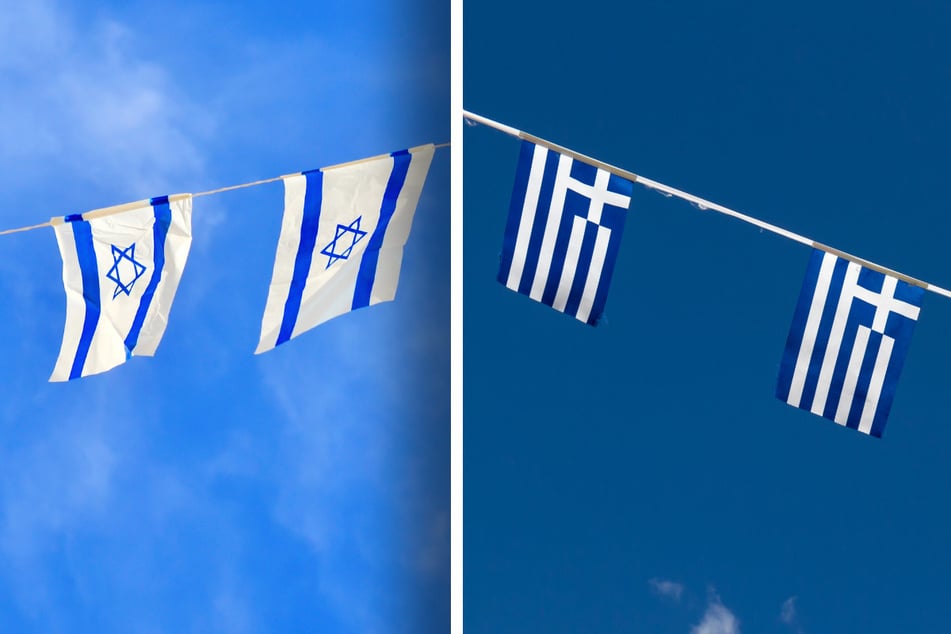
[0,0,450,634]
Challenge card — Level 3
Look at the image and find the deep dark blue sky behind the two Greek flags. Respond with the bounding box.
[463,0,951,634]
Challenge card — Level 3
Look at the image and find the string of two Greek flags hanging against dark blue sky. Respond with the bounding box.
[463,111,951,438]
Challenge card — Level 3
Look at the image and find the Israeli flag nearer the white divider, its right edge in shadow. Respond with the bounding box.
[255,144,435,354]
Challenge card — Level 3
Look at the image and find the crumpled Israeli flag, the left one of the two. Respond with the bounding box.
[50,194,192,381]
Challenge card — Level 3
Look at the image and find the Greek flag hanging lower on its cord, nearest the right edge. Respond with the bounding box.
[776,249,924,437]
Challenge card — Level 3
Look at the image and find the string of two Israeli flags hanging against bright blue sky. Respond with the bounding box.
[0,144,448,382]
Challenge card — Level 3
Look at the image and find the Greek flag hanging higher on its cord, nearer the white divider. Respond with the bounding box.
[498,141,634,326]
